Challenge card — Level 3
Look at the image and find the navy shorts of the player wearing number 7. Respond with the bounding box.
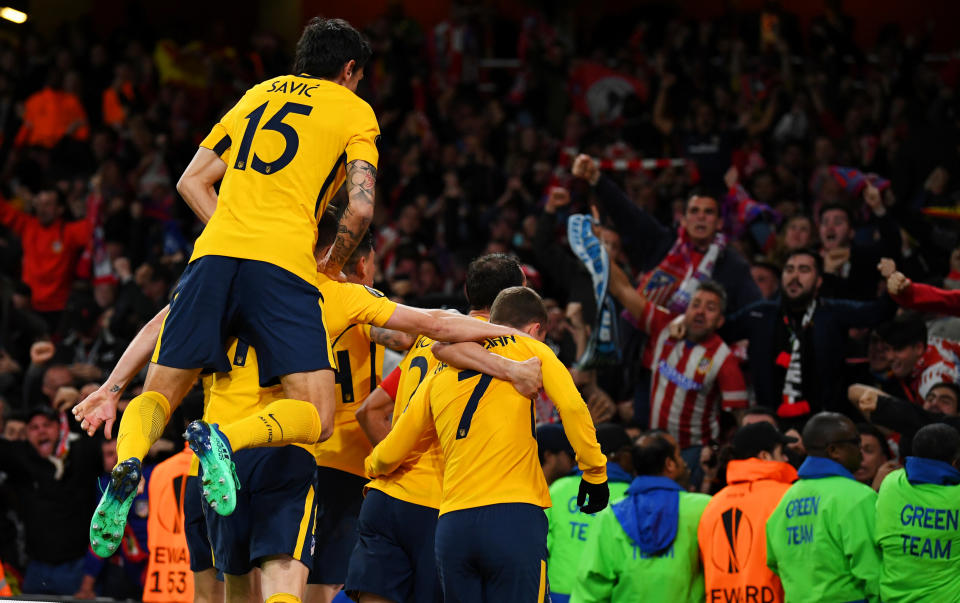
[436,503,548,603]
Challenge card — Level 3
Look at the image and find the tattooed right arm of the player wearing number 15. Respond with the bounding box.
[324,159,377,276]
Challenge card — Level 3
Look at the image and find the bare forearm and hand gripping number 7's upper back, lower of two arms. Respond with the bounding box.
[430,342,543,398]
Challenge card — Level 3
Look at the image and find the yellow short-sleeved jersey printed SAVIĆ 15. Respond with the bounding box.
[191,75,380,283]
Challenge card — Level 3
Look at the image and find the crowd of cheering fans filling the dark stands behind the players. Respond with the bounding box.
[0,2,960,600]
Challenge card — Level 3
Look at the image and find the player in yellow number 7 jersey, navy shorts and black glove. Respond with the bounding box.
[365,287,609,603]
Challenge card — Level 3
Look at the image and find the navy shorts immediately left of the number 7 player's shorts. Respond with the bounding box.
[344,489,443,603]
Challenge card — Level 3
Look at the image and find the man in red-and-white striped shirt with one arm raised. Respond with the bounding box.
[610,265,747,452]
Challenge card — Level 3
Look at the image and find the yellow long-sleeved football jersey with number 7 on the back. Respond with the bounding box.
[365,336,607,515]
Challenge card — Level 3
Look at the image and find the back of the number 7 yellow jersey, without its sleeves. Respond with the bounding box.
[424,336,555,515]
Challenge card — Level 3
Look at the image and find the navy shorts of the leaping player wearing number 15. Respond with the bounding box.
[153,255,333,387]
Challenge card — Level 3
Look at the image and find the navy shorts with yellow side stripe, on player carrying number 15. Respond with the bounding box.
[201,446,317,576]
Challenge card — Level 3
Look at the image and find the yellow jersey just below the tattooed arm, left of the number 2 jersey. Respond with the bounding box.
[314,275,397,477]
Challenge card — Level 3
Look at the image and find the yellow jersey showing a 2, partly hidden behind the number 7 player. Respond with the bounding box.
[367,335,443,509]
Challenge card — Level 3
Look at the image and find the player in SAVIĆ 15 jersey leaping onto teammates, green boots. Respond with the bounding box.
[94,18,379,576]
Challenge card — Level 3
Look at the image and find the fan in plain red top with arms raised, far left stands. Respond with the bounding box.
[0,190,93,328]
